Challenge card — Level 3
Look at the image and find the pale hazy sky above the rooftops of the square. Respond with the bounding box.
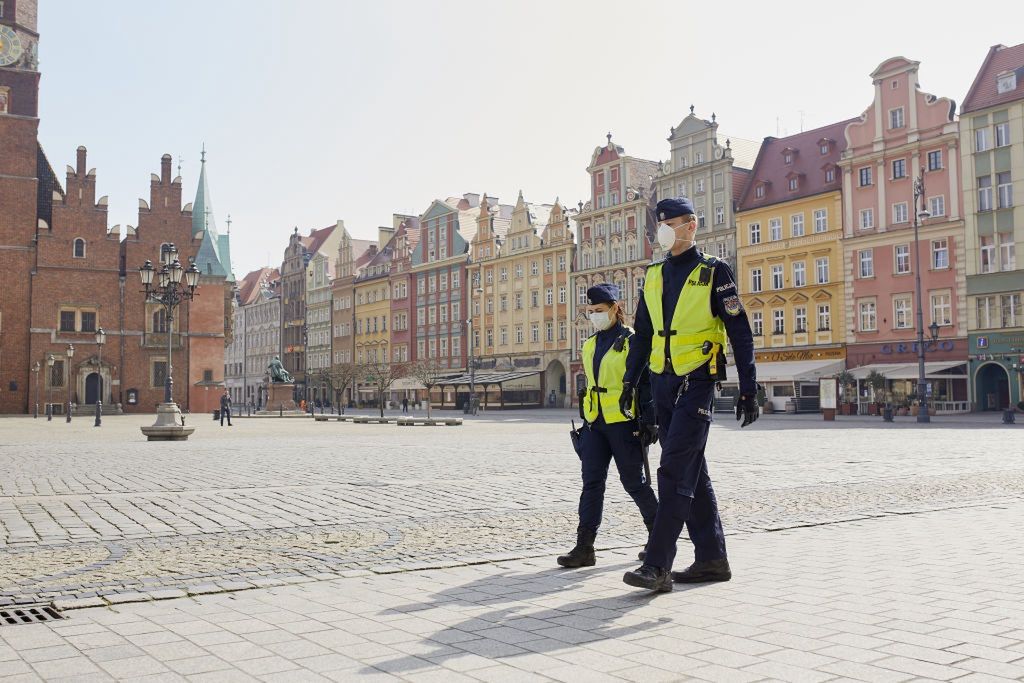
[40,0,1007,278]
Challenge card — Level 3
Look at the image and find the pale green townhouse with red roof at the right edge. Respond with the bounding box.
[959,44,1024,411]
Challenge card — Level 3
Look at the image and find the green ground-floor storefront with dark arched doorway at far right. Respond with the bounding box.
[968,332,1024,411]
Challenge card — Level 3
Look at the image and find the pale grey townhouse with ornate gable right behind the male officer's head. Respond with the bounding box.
[653,105,758,265]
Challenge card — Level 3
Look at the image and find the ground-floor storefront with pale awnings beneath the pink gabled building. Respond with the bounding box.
[847,339,971,415]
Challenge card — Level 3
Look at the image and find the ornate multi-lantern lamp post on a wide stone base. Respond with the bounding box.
[138,245,200,440]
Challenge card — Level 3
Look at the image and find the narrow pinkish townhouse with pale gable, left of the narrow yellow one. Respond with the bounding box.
[331,229,375,405]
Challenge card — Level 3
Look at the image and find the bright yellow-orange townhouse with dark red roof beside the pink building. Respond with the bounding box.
[730,121,849,411]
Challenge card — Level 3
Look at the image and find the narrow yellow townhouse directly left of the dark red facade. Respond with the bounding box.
[352,227,394,404]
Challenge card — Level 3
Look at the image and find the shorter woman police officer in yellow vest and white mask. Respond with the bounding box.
[558,284,657,567]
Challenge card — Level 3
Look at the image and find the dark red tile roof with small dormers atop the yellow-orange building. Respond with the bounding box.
[739,118,860,211]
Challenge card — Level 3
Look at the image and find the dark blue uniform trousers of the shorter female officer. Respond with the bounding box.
[580,418,657,531]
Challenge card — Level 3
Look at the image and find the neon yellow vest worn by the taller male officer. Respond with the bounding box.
[643,263,725,375]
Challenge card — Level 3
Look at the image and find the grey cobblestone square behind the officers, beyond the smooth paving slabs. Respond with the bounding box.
[0,412,1024,607]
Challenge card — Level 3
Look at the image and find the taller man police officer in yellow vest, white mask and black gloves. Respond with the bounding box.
[623,198,759,592]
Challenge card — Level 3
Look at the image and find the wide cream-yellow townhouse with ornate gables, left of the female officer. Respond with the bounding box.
[468,193,574,408]
